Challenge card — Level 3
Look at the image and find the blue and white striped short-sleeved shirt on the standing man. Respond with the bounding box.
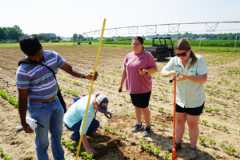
[16,50,64,99]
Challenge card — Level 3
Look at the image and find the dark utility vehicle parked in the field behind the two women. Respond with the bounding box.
[145,37,175,61]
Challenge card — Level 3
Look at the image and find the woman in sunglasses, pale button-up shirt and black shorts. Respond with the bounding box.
[161,39,208,151]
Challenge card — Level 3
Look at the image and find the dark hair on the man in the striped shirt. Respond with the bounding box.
[19,36,42,56]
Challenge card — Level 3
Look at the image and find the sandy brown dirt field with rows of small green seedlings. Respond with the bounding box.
[0,46,240,160]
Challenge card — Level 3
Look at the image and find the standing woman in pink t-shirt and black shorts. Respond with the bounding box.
[119,37,157,136]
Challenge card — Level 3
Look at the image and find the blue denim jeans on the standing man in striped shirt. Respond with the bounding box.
[28,99,64,160]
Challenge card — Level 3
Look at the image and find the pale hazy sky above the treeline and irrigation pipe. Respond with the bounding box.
[0,0,240,36]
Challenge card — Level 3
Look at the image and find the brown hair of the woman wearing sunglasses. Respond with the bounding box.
[175,38,197,68]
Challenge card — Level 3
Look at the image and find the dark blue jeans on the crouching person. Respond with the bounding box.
[66,119,100,141]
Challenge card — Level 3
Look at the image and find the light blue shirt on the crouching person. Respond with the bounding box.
[63,96,96,134]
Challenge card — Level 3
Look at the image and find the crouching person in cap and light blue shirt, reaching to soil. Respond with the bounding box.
[63,94,111,154]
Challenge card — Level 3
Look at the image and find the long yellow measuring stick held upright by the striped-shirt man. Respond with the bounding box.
[75,18,106,160]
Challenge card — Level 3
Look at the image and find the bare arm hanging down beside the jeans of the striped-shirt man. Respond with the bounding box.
[18,89,33,133]
